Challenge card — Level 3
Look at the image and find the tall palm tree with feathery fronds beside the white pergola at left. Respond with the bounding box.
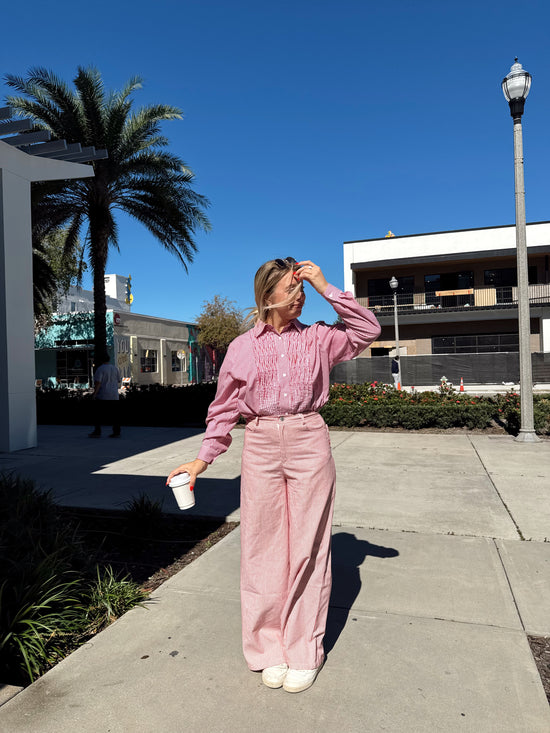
[5,67,210,356]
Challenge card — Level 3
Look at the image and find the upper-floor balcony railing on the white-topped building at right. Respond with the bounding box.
[357,283,550,315]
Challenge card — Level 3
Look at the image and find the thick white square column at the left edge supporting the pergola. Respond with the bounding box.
[0,168,37,451]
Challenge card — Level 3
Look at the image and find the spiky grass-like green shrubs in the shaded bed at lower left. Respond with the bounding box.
[0,474,149,684]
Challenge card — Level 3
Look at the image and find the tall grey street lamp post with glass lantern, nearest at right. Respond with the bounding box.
[502,58,539,443]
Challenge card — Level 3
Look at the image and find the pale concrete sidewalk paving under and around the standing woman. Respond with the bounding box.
[0,426,550,733]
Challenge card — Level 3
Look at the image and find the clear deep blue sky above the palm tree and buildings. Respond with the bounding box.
[0,0,550,322]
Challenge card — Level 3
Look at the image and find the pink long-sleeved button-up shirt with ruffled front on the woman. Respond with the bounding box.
[198,285,380,463]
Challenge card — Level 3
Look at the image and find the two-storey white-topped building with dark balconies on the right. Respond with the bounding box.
[336,222,550,384]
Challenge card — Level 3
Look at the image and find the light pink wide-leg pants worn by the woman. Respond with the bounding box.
[241,412,335,670]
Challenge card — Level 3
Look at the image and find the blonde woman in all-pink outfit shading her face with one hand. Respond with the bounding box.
[168,257,380,692]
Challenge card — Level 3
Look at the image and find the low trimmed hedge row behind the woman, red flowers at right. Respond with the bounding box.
[37,382,550,435]
